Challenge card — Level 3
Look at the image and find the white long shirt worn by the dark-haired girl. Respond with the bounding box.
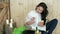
[26,10,46,31]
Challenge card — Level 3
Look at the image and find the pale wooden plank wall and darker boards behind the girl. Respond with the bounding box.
[0,0,60,34]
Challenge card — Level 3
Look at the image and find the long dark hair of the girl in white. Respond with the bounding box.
[36,2,48,22]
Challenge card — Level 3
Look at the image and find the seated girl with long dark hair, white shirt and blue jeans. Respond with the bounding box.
[25,2,58,34]
